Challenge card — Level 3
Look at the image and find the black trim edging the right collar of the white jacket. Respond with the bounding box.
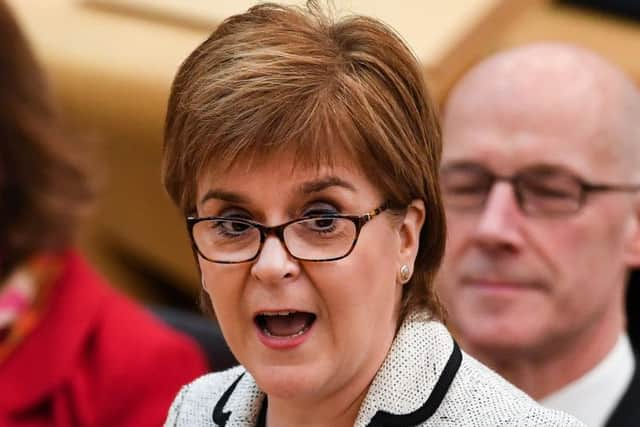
[367,340,462,427]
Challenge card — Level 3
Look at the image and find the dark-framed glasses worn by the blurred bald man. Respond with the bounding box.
[440,163,640,216]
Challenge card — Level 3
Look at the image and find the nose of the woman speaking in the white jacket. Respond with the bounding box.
[251,235,300,283]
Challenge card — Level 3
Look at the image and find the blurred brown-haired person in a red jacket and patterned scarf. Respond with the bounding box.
[0,2,206,427]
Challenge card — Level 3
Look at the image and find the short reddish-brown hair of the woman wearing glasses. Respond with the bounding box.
[163,2,446,317]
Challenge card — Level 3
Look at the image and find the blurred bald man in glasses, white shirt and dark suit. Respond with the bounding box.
[437,43,640,426]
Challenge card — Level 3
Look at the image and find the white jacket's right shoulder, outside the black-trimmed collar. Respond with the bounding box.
[428,353,584,427]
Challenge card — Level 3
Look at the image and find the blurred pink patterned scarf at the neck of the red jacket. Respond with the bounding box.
[0,254,63,363]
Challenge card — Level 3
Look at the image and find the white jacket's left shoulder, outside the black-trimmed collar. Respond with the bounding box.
[164,366,246,427]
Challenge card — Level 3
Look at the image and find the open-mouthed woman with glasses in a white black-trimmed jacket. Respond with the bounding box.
[164,4,578,426]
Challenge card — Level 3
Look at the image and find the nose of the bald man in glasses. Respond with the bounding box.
[474,181,524,250]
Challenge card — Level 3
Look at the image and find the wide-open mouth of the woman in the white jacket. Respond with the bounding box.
[254,311,316,348]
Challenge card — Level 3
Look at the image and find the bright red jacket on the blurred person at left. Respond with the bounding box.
[0,252,207,427]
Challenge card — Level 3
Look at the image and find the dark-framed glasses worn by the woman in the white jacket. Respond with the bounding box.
[187,203,389,264]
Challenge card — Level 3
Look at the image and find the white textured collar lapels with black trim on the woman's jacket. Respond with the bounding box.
[212,315,462,427]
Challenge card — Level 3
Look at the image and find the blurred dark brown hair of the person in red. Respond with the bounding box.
[0,1,94,277]
